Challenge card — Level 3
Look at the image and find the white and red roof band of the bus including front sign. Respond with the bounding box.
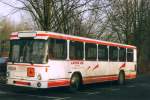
[10,31,136,49]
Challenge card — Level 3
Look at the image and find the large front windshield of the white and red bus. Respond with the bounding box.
[9,39,48,64]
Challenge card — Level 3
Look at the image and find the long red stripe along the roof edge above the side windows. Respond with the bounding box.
[36,33,136,49]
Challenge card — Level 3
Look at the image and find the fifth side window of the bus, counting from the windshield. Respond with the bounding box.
[109,46,118,61]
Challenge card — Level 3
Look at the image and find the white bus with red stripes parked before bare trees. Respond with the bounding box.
[7,31,137,90]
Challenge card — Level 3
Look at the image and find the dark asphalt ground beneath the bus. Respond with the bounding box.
[0,75,150,100]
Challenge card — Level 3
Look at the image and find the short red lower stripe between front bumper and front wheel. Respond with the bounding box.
[48,79,70,87]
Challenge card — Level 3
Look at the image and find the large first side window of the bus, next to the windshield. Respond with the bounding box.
[48,39,67,59]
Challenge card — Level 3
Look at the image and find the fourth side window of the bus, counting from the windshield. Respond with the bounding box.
[98,45,108,61]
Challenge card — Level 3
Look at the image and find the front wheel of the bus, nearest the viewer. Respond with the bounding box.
[70,74,82,92]
